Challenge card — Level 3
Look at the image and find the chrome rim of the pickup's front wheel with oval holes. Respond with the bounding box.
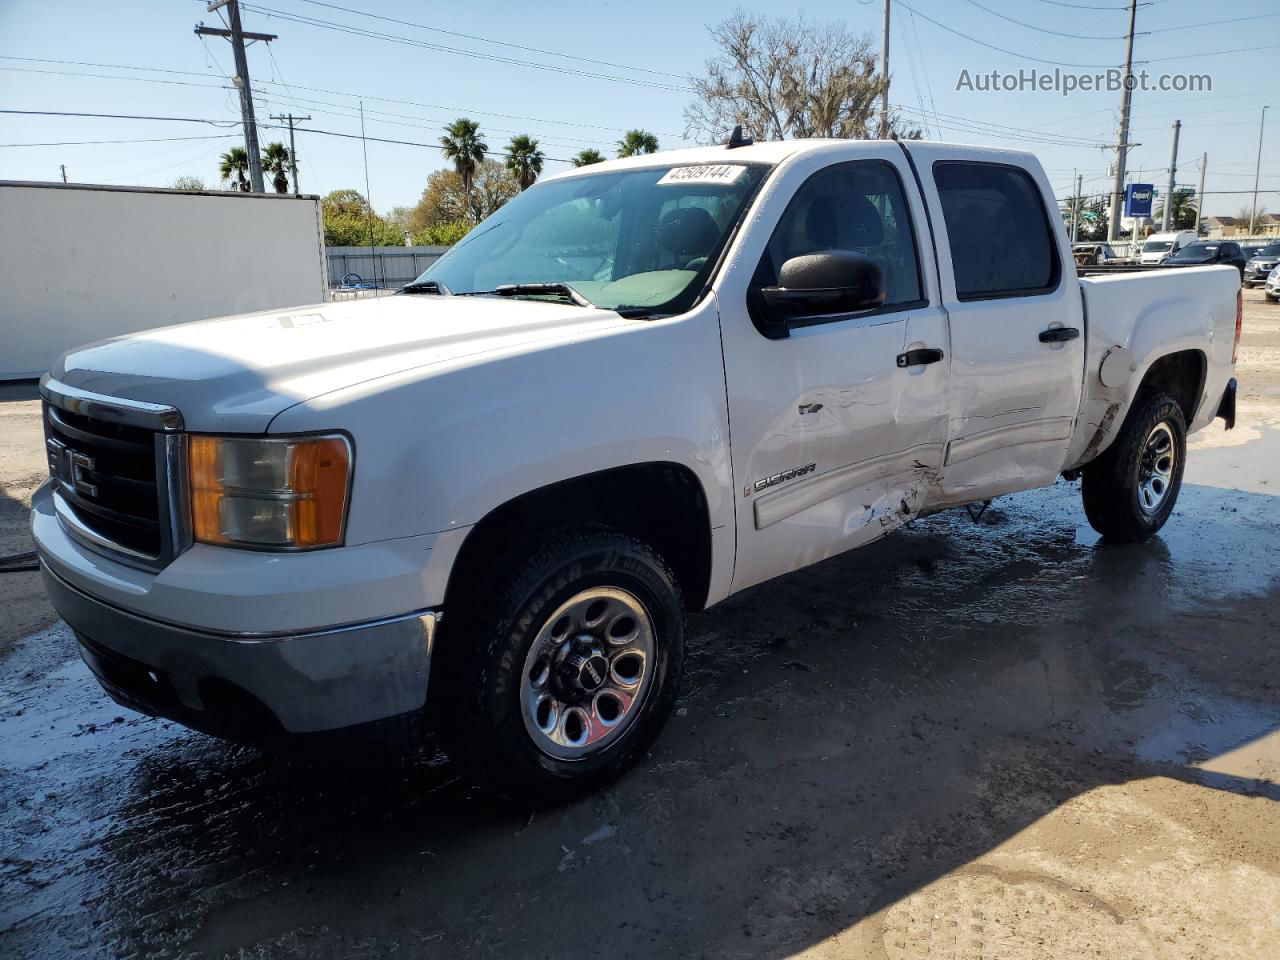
[520,586,654,760]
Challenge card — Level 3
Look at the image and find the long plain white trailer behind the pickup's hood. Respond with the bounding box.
[0,180,325,380]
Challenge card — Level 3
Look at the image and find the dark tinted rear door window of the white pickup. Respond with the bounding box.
[933,160,1061,301]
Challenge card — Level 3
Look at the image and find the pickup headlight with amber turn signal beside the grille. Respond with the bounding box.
[189,434,351,550]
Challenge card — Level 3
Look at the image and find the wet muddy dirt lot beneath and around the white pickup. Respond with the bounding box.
[0,291,1280,960]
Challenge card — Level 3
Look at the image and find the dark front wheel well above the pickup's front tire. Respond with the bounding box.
[444,463,712,611]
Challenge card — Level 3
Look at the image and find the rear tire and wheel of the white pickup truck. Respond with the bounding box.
[1080,393,1187,543]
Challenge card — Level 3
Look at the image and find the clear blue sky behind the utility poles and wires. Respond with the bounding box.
[0,0,1280,214]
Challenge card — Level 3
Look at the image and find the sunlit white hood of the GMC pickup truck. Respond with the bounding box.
[51,294,634,433]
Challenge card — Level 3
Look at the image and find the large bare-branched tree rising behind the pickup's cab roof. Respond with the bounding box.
[685,9,920,143]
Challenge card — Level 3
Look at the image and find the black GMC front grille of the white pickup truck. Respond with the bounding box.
[45,401,168,561]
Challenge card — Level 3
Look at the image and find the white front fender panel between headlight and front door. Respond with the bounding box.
[271,298,732,552]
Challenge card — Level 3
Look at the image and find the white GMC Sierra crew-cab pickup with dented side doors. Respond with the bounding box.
[32,141,1240,801]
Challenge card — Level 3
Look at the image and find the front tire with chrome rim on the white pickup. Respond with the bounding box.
[440,527,685,806]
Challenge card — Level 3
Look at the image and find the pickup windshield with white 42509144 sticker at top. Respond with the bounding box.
[412,164,769,314]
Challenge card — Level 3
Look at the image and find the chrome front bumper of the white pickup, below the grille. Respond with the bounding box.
[41,564,440,741]
